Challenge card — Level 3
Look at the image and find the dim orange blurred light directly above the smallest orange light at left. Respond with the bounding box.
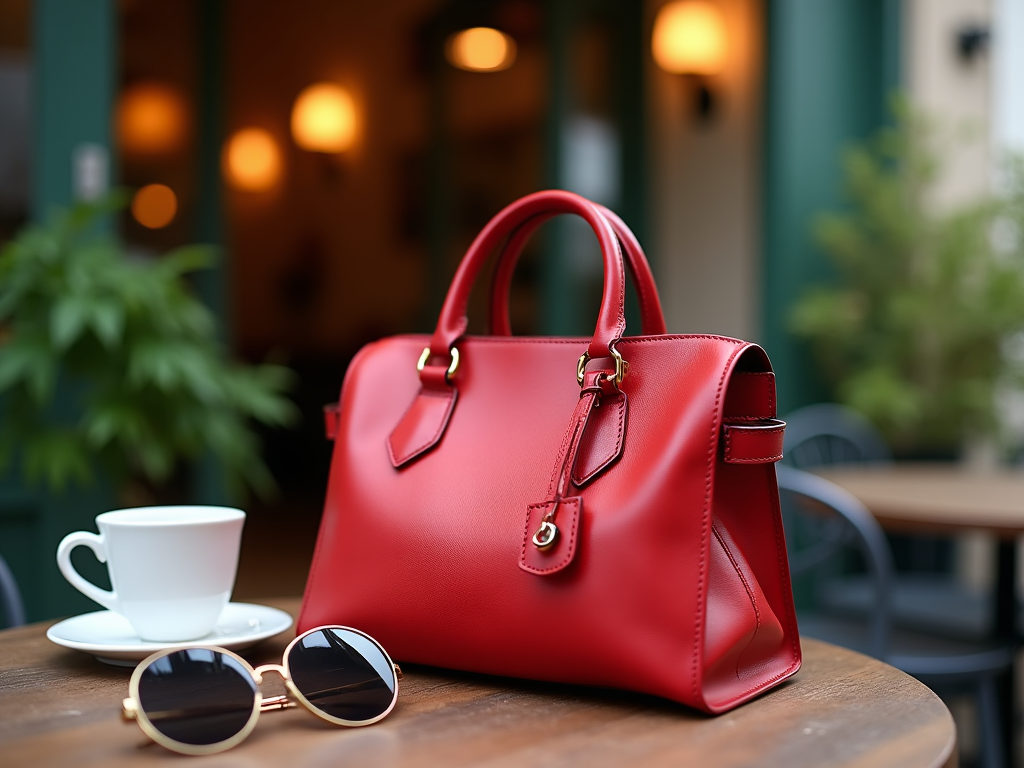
[117,83,186,155]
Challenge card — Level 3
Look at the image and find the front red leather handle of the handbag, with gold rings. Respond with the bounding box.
[420,189,626,372]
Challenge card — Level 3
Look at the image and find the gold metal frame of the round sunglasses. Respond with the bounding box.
[121,624,401,755]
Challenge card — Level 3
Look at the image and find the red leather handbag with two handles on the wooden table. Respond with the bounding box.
[298,191,800,713]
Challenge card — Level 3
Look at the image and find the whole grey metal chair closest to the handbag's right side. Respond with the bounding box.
[778,466,1013,768]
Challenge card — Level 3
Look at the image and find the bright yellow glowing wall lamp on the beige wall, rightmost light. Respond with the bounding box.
[651,0,726,75]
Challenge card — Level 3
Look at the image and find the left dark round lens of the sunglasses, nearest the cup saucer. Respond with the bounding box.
[138,648,256,745]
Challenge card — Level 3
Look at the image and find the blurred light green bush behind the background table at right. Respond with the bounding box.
[791,99,1024,452]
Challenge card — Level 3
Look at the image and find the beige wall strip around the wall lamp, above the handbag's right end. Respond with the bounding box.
[644,0,764,340]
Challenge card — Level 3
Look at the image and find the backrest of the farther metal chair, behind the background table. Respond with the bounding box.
[782,402,892,469]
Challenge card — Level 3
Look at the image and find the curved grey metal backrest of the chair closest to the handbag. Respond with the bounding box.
[777,466,894,658]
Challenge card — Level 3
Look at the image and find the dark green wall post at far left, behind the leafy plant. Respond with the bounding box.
[0,0,117,621]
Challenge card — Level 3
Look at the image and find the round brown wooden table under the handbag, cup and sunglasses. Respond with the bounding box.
[0,600,956,768]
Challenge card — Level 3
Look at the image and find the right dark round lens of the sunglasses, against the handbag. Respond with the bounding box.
[288,628,396,723]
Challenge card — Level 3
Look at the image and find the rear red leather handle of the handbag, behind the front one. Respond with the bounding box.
[489,203,668,336]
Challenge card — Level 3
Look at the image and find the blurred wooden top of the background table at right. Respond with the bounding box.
[815,463,1024,539]
